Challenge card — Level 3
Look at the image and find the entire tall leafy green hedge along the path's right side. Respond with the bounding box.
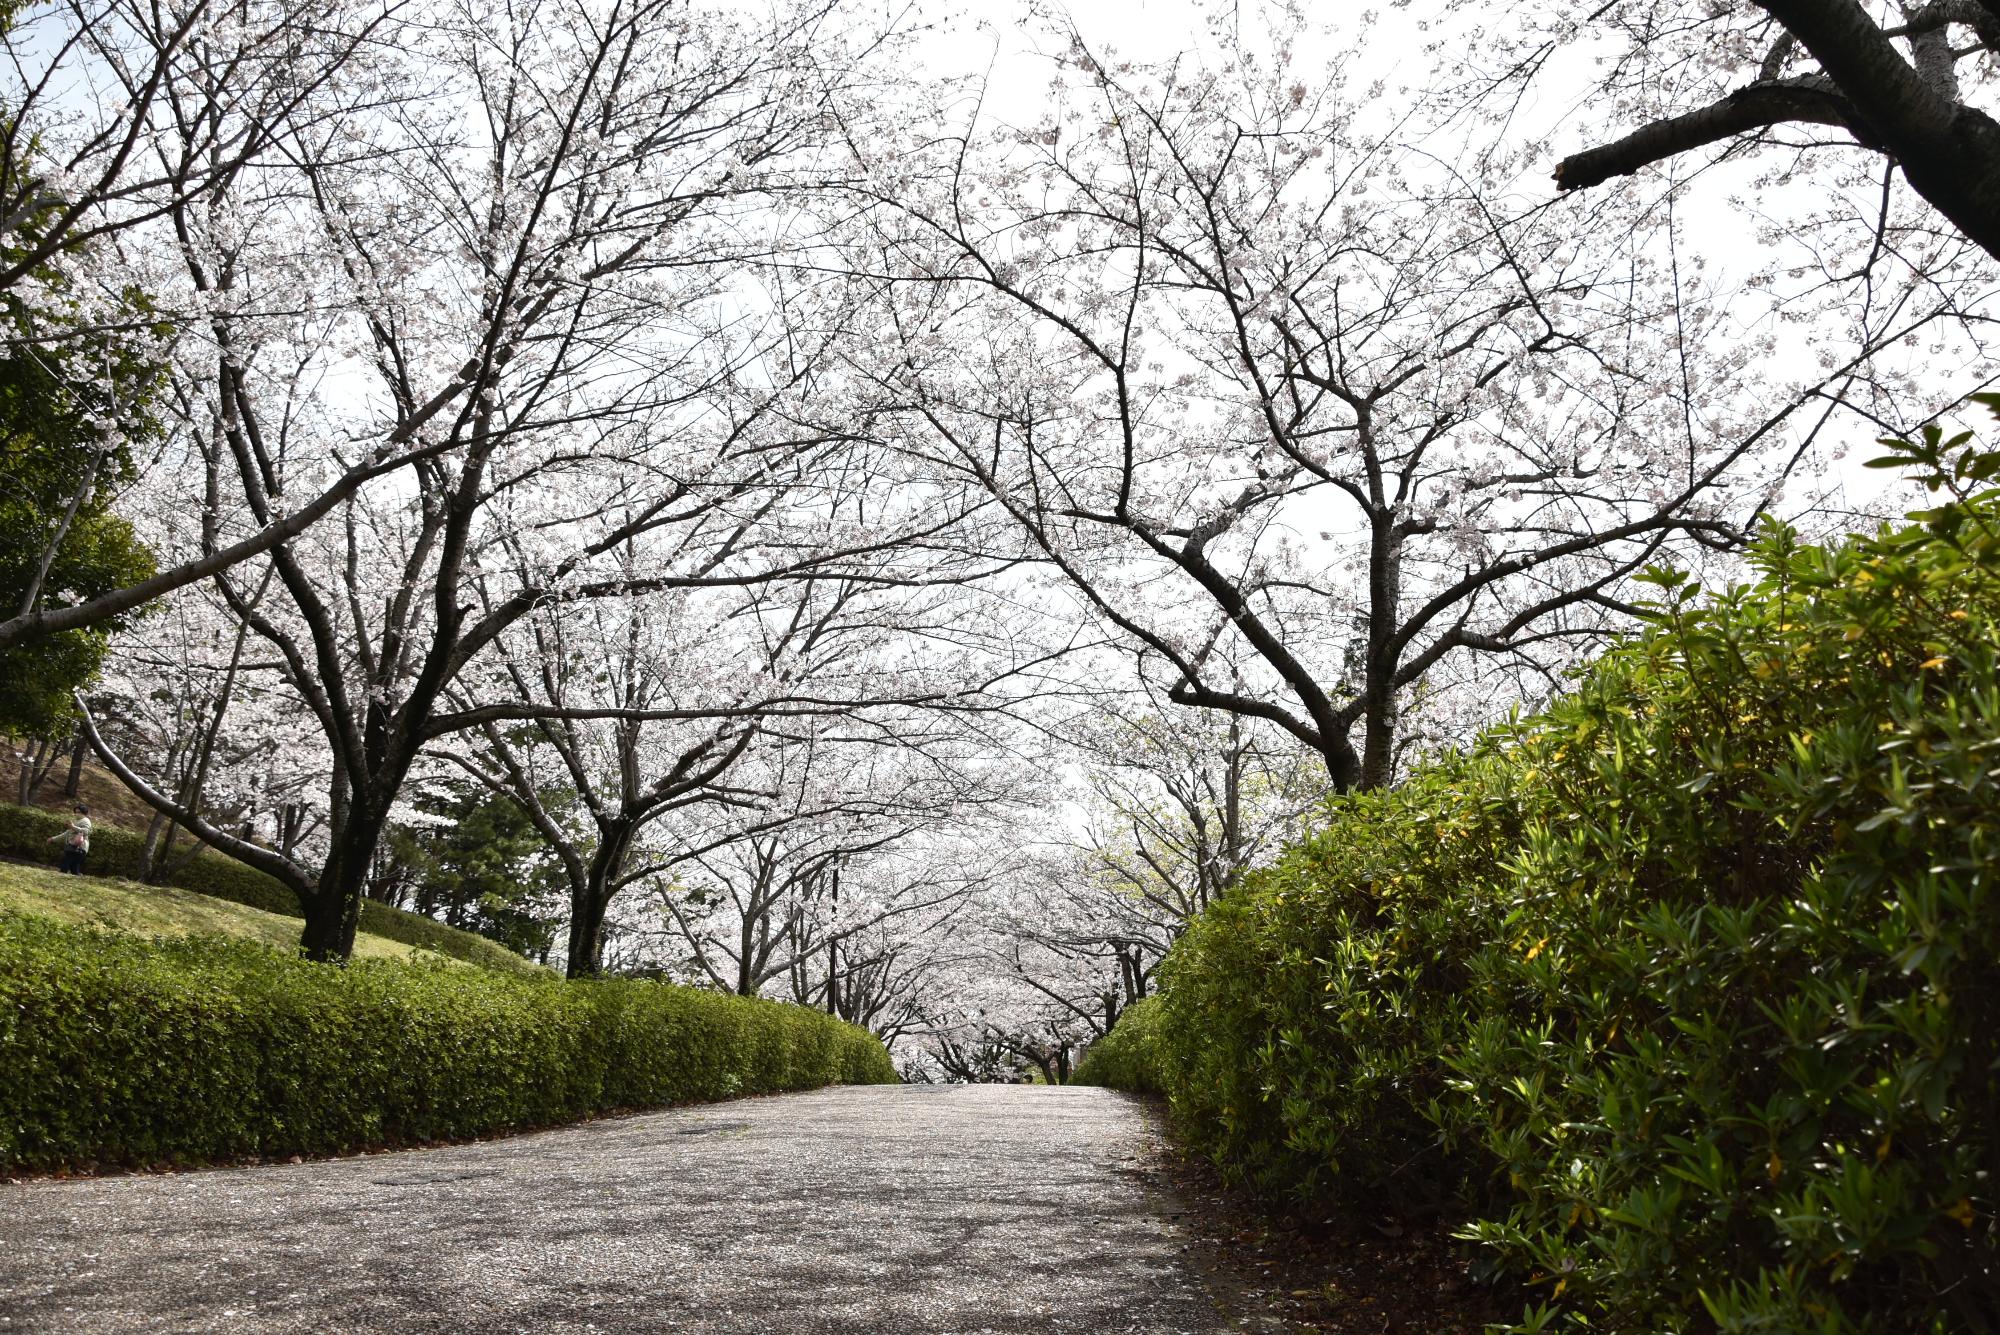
[1100,469,2000,1333]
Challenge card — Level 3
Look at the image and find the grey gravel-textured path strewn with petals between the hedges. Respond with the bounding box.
[0,1085,1234,1335]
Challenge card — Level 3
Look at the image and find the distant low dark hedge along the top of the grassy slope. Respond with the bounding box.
[0,805,534,973]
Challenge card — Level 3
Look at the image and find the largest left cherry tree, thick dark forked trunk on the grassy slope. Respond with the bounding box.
[72,0,928,957]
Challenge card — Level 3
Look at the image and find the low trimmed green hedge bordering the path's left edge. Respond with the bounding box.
[0,915,896,1169]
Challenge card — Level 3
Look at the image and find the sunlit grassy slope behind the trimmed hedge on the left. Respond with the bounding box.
[0,863,458,963]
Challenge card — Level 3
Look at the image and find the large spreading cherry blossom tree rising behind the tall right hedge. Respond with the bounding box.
[832,14,1964,787]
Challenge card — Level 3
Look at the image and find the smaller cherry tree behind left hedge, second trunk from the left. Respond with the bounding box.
[452,559,1042,981]
